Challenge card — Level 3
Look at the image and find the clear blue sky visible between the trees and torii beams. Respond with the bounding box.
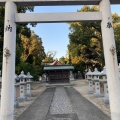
[30,5,120,59]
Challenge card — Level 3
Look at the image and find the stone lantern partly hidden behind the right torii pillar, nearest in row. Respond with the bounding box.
[100,67,109,104]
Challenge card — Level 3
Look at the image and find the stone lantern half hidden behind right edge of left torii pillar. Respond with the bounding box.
[14,74,20,107]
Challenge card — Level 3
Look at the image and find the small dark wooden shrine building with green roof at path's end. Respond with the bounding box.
[44,60,74,83]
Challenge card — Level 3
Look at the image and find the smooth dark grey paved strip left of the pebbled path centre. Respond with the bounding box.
[17,88,55,120]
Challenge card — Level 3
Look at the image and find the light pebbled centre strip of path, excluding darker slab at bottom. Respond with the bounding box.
[50,87,74,114]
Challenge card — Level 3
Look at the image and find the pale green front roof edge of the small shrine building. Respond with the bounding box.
[44,65,74,71]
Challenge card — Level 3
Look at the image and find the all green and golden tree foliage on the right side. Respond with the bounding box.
[68,6,120,75]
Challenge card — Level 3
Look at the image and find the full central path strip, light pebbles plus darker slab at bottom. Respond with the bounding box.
[46,87,78,120]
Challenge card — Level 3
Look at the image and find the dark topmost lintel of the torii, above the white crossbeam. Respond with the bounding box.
[0,0,120,6]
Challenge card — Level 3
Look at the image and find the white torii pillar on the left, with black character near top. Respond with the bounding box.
[0,0,17,120]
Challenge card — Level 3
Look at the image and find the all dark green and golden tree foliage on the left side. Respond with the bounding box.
[0,6,45,79]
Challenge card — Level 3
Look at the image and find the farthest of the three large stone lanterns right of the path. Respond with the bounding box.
[86,69,94,94]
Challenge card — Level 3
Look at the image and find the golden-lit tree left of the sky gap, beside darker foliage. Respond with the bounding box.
[21,33,45,65]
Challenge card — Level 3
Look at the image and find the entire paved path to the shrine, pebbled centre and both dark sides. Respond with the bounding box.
[17,86,110,120]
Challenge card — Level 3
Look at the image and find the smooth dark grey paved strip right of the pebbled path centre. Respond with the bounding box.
[66,88,111,120]
